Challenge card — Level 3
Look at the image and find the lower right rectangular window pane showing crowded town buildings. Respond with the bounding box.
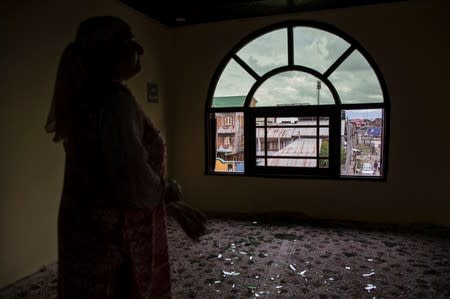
[341,109,384,176]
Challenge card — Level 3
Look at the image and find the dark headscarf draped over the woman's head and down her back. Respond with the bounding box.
[45,16,133,142]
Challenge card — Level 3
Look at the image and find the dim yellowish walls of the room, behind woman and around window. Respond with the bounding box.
[0,0,450,287]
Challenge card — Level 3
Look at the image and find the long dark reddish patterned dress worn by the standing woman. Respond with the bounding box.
[58,82,171,299]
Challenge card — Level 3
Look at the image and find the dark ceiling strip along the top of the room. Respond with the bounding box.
[120,0,408,27]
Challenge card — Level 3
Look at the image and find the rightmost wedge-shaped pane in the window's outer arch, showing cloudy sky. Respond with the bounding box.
[329,51,383,104]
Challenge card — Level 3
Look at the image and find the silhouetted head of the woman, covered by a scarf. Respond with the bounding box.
[75,16,143,80]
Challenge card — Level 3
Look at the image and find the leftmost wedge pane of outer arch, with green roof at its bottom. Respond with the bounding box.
[212,59,255,107]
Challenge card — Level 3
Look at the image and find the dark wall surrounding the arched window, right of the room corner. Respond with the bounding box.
[168,0,450,225]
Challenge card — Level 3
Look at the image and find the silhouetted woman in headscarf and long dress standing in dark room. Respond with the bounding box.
[46,16,205,299]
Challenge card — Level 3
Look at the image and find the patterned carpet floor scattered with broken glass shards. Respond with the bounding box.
[0,218,450,299]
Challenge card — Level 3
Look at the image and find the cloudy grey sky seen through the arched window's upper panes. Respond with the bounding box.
[214,27,383,106]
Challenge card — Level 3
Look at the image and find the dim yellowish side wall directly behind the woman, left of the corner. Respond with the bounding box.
[0,0,169,287]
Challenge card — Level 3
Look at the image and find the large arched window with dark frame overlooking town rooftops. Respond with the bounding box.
[206,22,389,179]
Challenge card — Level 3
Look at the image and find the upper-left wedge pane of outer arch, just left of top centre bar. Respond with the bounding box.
[237,29,288,76]
